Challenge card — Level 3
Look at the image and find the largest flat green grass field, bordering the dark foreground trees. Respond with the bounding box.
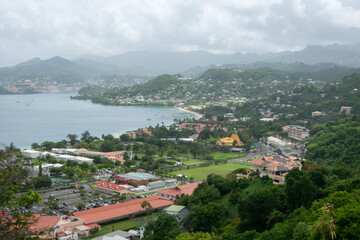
[172,163,250,180]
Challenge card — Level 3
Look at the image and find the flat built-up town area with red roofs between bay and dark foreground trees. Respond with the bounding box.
[6,107,316,239]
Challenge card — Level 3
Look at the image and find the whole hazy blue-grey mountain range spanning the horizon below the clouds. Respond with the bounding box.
[0,44,360,81]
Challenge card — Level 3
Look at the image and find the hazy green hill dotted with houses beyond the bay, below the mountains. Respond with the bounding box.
[75,68,355,105]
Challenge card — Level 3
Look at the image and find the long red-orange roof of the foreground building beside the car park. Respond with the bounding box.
[73,196,173,224]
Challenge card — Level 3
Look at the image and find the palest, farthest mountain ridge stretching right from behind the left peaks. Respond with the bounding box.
[76,44,360,75]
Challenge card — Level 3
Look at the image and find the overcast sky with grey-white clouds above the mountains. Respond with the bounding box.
[0,0,360,66]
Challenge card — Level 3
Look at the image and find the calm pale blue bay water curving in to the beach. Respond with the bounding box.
[0,93,196,148]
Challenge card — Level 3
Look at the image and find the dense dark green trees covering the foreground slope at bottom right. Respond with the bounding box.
[145,163,360,240]
